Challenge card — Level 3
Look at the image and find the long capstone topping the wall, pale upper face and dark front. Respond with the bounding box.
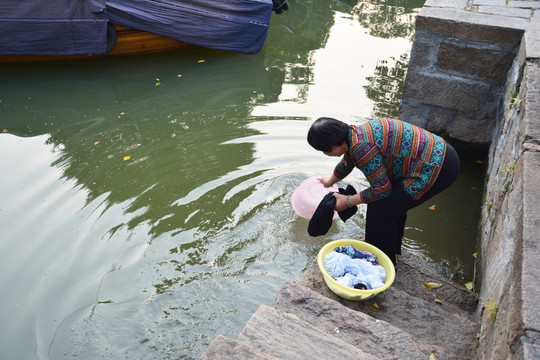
[416,7,529,45]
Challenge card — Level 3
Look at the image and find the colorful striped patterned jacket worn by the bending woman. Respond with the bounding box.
[334,118,446,203]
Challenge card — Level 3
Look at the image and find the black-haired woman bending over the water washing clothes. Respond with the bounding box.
[307,118,460,264]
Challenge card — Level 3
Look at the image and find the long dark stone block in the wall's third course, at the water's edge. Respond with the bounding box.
[402,71,490,112]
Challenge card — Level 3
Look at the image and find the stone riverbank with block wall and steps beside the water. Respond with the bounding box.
[202,0,540,360]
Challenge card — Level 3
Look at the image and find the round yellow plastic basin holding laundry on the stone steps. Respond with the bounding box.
[317,239,396,301]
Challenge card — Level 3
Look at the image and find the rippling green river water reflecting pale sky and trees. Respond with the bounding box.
[0,0,483,359]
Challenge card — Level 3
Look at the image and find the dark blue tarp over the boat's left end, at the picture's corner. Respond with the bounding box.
[0,0,107,55]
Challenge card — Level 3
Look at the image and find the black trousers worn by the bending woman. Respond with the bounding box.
[366,143,460,265]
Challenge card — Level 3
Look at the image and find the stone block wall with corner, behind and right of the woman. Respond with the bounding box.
[400,0,540,360]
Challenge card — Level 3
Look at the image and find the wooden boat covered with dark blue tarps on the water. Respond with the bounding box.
[0,0,288,63]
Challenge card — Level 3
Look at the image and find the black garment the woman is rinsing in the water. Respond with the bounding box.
[308,185,358,236]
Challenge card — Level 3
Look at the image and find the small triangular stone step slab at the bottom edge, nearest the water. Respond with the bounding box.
[199,335,280,360]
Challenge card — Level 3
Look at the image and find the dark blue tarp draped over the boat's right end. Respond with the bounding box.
[107,0,272,53]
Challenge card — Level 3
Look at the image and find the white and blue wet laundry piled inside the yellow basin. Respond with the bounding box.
[324,248,386,290]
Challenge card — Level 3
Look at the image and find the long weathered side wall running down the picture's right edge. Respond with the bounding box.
[479,35,540,360]
